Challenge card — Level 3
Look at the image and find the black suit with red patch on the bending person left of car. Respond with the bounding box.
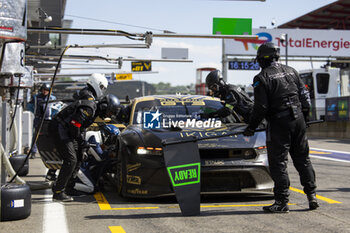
[51,100,97,193]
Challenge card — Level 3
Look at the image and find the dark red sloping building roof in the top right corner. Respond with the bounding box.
[278,0,350,30]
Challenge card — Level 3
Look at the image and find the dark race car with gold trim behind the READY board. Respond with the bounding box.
[111,95,273,197]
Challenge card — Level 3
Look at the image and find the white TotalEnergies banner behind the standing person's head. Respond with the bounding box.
[225,29,350,57]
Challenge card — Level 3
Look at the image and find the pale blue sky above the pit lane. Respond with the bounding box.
[65,0,335,85]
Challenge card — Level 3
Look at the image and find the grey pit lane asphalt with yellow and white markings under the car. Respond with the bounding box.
[0,138,350,233]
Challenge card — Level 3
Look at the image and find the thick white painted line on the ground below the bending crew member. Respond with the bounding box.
[43,189,69,233]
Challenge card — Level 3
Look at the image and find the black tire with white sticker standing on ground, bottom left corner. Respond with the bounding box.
[1,183,32,221]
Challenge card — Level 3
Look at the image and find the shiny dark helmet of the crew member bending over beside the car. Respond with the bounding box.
[97,94,121,118]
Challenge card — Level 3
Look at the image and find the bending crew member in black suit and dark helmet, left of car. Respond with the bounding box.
[51,95,120,202]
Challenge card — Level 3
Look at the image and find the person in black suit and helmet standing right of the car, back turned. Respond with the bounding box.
[244,42,319,213]
